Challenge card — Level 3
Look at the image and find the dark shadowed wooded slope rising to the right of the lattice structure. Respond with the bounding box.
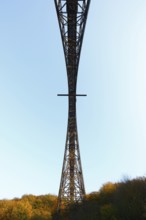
[54,178,146,220]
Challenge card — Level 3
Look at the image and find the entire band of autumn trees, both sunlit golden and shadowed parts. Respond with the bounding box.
[0,178,146,220]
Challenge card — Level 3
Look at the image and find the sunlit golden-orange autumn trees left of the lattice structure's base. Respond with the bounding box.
[0,195,57,220]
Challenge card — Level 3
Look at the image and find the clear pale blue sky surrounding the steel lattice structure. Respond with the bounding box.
[0,0,146,199]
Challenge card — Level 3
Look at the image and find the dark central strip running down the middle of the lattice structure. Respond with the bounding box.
[67,0,77,201]
